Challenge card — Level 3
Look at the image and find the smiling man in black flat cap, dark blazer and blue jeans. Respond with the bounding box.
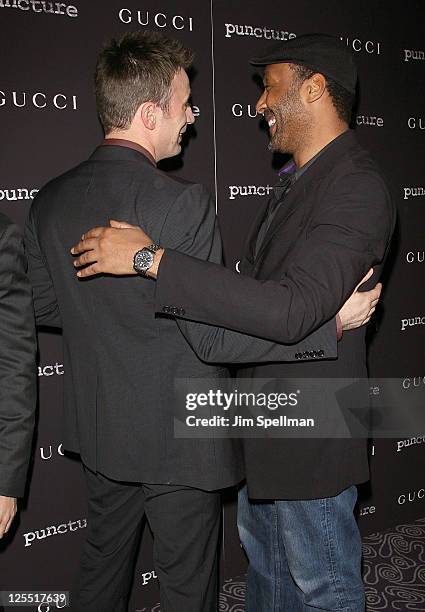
[74,34,395,612]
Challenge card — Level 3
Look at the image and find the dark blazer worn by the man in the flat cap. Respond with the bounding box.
[156,131,395,499]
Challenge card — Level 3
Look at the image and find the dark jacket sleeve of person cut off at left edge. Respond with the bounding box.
[0,214,37,497]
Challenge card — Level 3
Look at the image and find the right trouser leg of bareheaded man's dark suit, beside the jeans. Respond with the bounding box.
[143,484,221,612]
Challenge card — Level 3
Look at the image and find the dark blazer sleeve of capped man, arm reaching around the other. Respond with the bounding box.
[156,172,394,344]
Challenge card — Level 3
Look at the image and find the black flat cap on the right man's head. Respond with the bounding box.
[249,34,357,93]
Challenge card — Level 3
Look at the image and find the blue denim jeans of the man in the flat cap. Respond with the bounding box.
[238,486,365,612]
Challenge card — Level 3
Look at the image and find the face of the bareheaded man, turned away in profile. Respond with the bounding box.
[156,69,195,160]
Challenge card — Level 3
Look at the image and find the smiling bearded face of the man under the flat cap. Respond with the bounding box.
[257,63,311,155]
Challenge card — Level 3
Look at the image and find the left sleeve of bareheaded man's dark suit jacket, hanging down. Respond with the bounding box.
[24,204,62,327]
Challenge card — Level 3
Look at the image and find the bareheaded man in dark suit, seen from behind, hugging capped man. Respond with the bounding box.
[26,32,373,612]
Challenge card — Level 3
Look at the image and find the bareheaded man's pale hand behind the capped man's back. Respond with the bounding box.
[338,268,382,331]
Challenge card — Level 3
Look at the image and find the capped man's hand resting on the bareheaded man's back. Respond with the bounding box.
[71,220,164,278]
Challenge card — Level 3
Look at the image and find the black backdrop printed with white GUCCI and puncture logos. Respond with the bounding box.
[0,0,425,612]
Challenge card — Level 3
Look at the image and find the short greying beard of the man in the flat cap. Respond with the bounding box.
[268,84,311,155]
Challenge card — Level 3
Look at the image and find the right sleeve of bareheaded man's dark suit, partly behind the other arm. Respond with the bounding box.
[161,185,337,364]
